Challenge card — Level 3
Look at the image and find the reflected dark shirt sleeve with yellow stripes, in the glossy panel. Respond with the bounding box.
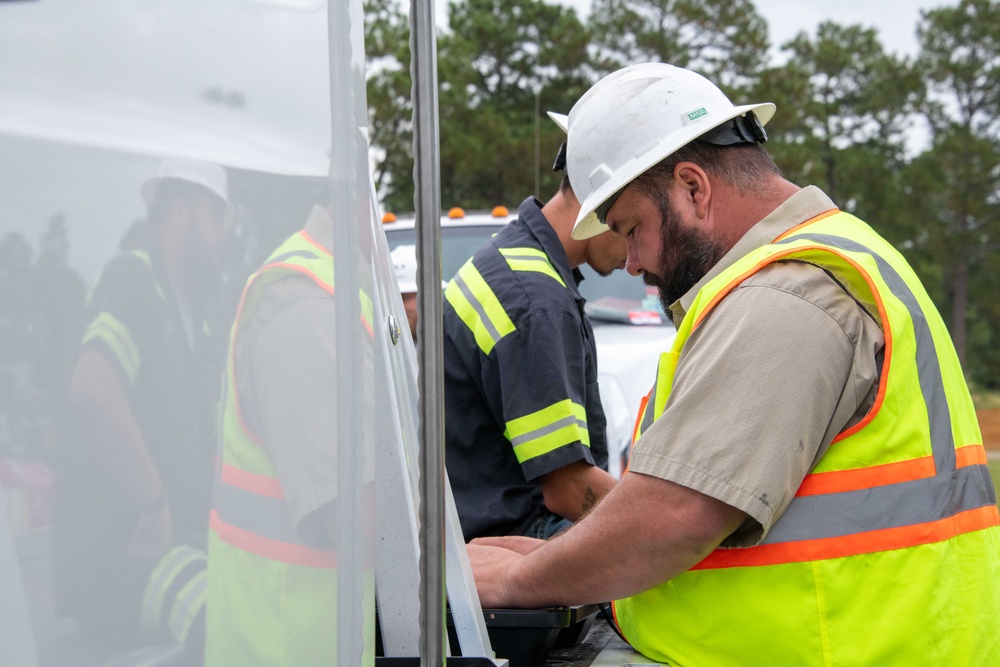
[80,253,160,390]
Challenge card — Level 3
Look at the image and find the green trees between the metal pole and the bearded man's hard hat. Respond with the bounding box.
[438,0,591,208]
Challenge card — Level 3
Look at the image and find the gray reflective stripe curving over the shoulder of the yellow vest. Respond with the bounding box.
[775,233,955,472]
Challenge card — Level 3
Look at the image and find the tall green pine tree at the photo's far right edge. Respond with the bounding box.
[910,0,1000,376]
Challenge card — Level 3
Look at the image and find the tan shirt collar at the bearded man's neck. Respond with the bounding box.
[670,185,837,326]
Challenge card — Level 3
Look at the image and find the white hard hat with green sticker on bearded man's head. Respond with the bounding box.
[572,63,774,239]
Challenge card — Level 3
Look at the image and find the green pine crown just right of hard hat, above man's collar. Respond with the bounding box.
[756,22,919,217]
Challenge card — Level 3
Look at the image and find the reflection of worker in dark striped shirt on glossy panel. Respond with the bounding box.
[54,160,229,656]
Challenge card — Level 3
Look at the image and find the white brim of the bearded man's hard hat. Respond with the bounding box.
[576,102,775,241]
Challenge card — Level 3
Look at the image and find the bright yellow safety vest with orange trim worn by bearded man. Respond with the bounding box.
[614,210,1000,667]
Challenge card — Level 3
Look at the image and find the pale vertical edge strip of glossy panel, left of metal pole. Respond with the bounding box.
[328,0,374,665]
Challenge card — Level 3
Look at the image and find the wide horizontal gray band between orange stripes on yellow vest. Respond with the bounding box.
[761,465,994,544]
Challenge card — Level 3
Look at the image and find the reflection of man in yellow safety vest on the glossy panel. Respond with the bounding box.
[205,207,373,667]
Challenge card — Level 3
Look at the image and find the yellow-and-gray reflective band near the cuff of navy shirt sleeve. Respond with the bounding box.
[503,398,590,463]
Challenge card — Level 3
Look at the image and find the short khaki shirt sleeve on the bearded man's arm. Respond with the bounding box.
[629,262,884,546]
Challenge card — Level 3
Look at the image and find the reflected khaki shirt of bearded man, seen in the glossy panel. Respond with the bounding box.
[236,207,374,546]
